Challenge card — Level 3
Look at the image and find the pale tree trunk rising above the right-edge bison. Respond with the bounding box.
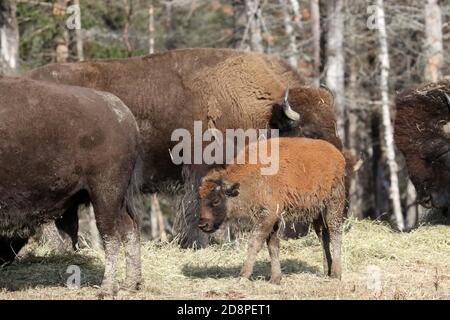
[425,0,444,81]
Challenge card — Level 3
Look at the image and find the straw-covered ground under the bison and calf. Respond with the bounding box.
[0,219,450,300]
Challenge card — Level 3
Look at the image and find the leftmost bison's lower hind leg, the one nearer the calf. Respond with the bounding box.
[120,214,143,291]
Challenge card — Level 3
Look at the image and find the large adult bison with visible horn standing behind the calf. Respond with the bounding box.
[28,49,344,246]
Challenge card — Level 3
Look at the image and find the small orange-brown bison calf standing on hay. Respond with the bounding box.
[199,138,345,283]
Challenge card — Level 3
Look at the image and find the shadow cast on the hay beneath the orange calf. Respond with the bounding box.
[182,259,322,280]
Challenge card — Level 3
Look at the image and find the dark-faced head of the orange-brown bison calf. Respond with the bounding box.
[198,179,240,233]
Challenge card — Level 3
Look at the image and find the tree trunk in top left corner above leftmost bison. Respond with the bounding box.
[0,0,19,74]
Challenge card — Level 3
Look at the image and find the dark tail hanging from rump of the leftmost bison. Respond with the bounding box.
[125,157,144,224]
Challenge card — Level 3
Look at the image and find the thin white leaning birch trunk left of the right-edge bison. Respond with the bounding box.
[377,0,405,231]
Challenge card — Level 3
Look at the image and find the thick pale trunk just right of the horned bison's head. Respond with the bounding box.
[326,0,346,141]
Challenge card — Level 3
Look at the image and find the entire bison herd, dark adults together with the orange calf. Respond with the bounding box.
[0,49,450,294]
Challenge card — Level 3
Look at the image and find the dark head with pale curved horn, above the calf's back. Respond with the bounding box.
[269,86,342,150]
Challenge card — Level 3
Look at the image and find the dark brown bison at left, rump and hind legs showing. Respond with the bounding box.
[0,77,141,292]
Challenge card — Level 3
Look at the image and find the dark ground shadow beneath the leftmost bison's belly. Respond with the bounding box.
[0,253,104,291]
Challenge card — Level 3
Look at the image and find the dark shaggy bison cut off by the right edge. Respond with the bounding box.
[395,80,450,208]
